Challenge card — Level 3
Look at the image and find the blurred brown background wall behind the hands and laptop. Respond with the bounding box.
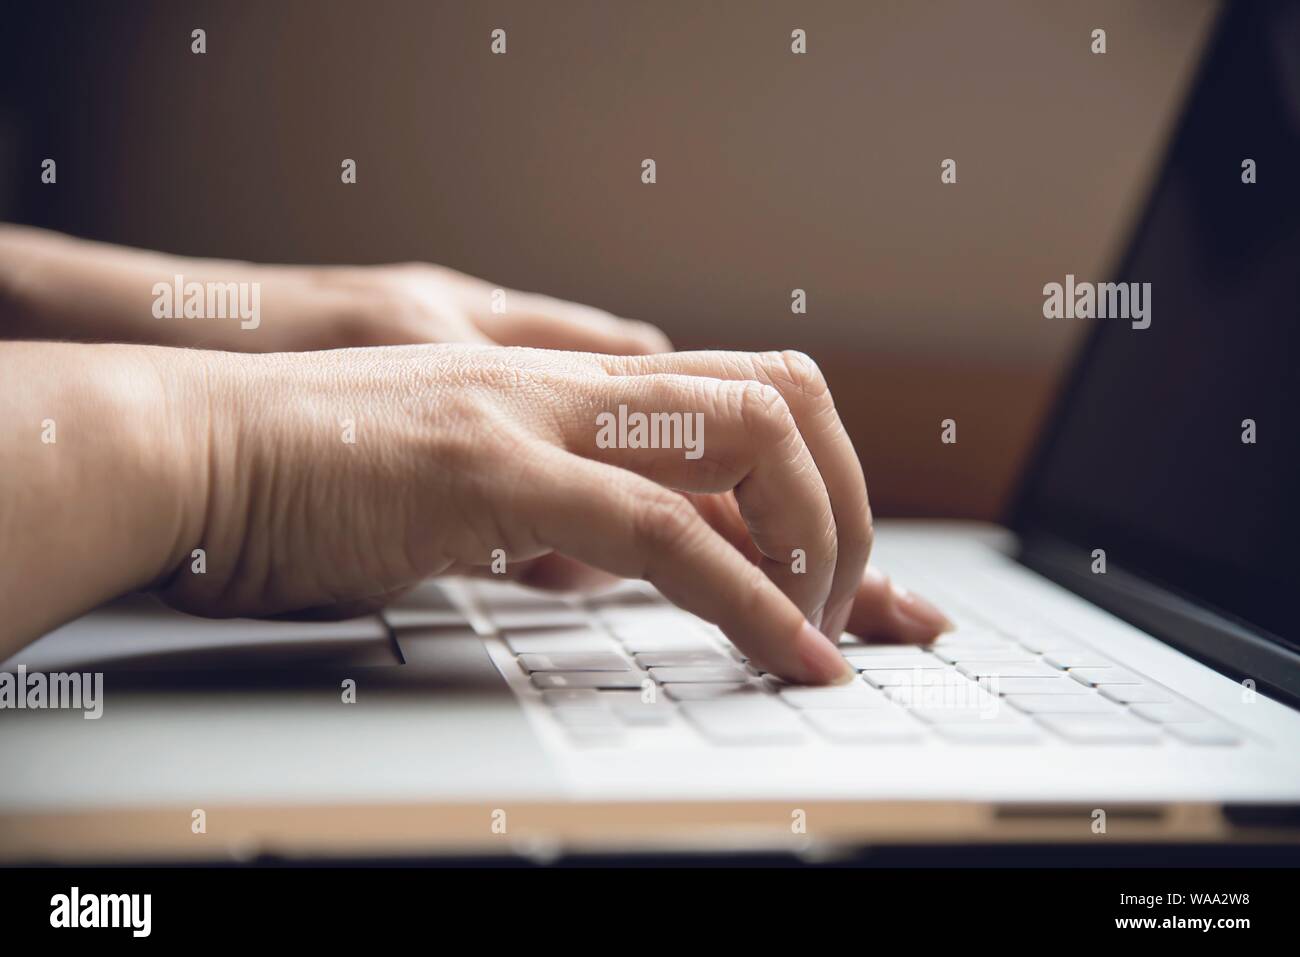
[0,0,1217,519]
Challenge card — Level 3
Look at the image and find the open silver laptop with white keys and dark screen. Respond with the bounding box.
[0,5,1300,862]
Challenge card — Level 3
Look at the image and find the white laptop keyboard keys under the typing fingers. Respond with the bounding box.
[441,572,1242,748]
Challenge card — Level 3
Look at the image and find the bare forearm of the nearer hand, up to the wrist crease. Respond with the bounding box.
[0,342,207,659]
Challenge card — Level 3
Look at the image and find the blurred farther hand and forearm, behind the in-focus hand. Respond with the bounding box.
[0,224,672,355]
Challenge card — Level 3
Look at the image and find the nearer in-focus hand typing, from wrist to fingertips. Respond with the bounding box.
[153,348,946,683]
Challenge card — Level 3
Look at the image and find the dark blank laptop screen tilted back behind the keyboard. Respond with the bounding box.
[1011,4,1300,648]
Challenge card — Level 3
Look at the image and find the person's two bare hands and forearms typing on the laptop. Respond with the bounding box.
[0,229,948,683]
